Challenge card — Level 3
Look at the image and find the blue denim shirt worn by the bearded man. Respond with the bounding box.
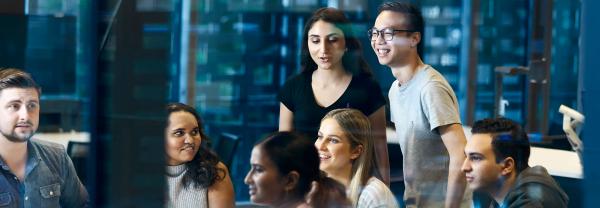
[0,140,89,208]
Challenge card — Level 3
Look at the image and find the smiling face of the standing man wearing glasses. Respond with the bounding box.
[371,11,421,67]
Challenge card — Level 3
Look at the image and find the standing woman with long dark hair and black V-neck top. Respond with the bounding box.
[278,8,389,182]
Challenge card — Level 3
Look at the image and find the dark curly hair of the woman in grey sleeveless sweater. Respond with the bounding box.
[167,103,226,188]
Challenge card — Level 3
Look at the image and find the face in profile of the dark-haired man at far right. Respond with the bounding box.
[461,134,503,192]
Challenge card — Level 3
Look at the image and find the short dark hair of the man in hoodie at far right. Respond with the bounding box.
[471,118,530,173]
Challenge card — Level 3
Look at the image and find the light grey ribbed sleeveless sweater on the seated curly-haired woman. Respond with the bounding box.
[165,164,208,208]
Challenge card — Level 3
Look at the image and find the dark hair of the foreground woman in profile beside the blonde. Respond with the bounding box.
[255,132,349,207]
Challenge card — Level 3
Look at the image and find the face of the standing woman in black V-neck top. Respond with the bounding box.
[308,20,346,69]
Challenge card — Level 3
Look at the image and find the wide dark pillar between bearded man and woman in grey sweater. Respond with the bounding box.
[92,1,171,207]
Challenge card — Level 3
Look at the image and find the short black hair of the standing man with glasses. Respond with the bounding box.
[378,1,425,56]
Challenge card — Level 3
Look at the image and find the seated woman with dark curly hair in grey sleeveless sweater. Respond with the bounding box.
[165,103,235,207]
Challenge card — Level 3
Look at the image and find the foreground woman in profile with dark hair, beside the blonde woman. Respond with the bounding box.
[244,132,351,207]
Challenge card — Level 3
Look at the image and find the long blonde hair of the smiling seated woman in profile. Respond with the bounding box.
[321,108,380,207]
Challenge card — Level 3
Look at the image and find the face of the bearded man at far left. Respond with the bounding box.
[0,88,40,142]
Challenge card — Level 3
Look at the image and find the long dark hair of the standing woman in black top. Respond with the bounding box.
[300,8,373,77]
